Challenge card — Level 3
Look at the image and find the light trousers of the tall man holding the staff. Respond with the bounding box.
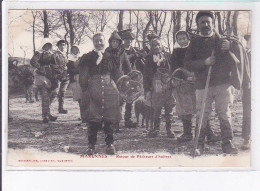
[196,84,234,143]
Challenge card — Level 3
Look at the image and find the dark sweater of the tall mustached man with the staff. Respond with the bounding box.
[184,34,235,89]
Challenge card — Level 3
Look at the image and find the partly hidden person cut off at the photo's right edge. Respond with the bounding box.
[242,34,251,150]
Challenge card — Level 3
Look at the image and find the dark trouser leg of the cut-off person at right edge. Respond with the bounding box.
[242,84,251,140]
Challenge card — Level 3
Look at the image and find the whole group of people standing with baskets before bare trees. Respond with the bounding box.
[9,11,251,155]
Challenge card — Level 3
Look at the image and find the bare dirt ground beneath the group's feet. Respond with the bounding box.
[8,88,248,155]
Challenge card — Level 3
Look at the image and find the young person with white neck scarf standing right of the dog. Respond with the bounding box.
[143,39,175,138]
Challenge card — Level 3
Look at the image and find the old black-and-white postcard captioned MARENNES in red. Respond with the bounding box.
[3,1,252,169]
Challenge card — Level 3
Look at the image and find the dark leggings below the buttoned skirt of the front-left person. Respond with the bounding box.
[88,122,114,146]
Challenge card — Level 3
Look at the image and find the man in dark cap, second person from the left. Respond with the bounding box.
[52,40,69,114]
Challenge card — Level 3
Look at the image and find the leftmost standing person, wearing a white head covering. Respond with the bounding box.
[30,38,58,123]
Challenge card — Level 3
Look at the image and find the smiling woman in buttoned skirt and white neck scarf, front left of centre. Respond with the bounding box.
[79,33,121,155]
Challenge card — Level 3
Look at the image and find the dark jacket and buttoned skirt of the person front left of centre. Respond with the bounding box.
[79,51,121,123]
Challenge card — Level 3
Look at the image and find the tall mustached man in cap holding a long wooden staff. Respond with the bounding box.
[184,11,238,154]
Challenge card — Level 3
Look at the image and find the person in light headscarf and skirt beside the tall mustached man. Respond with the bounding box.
[171,31,219,142]
